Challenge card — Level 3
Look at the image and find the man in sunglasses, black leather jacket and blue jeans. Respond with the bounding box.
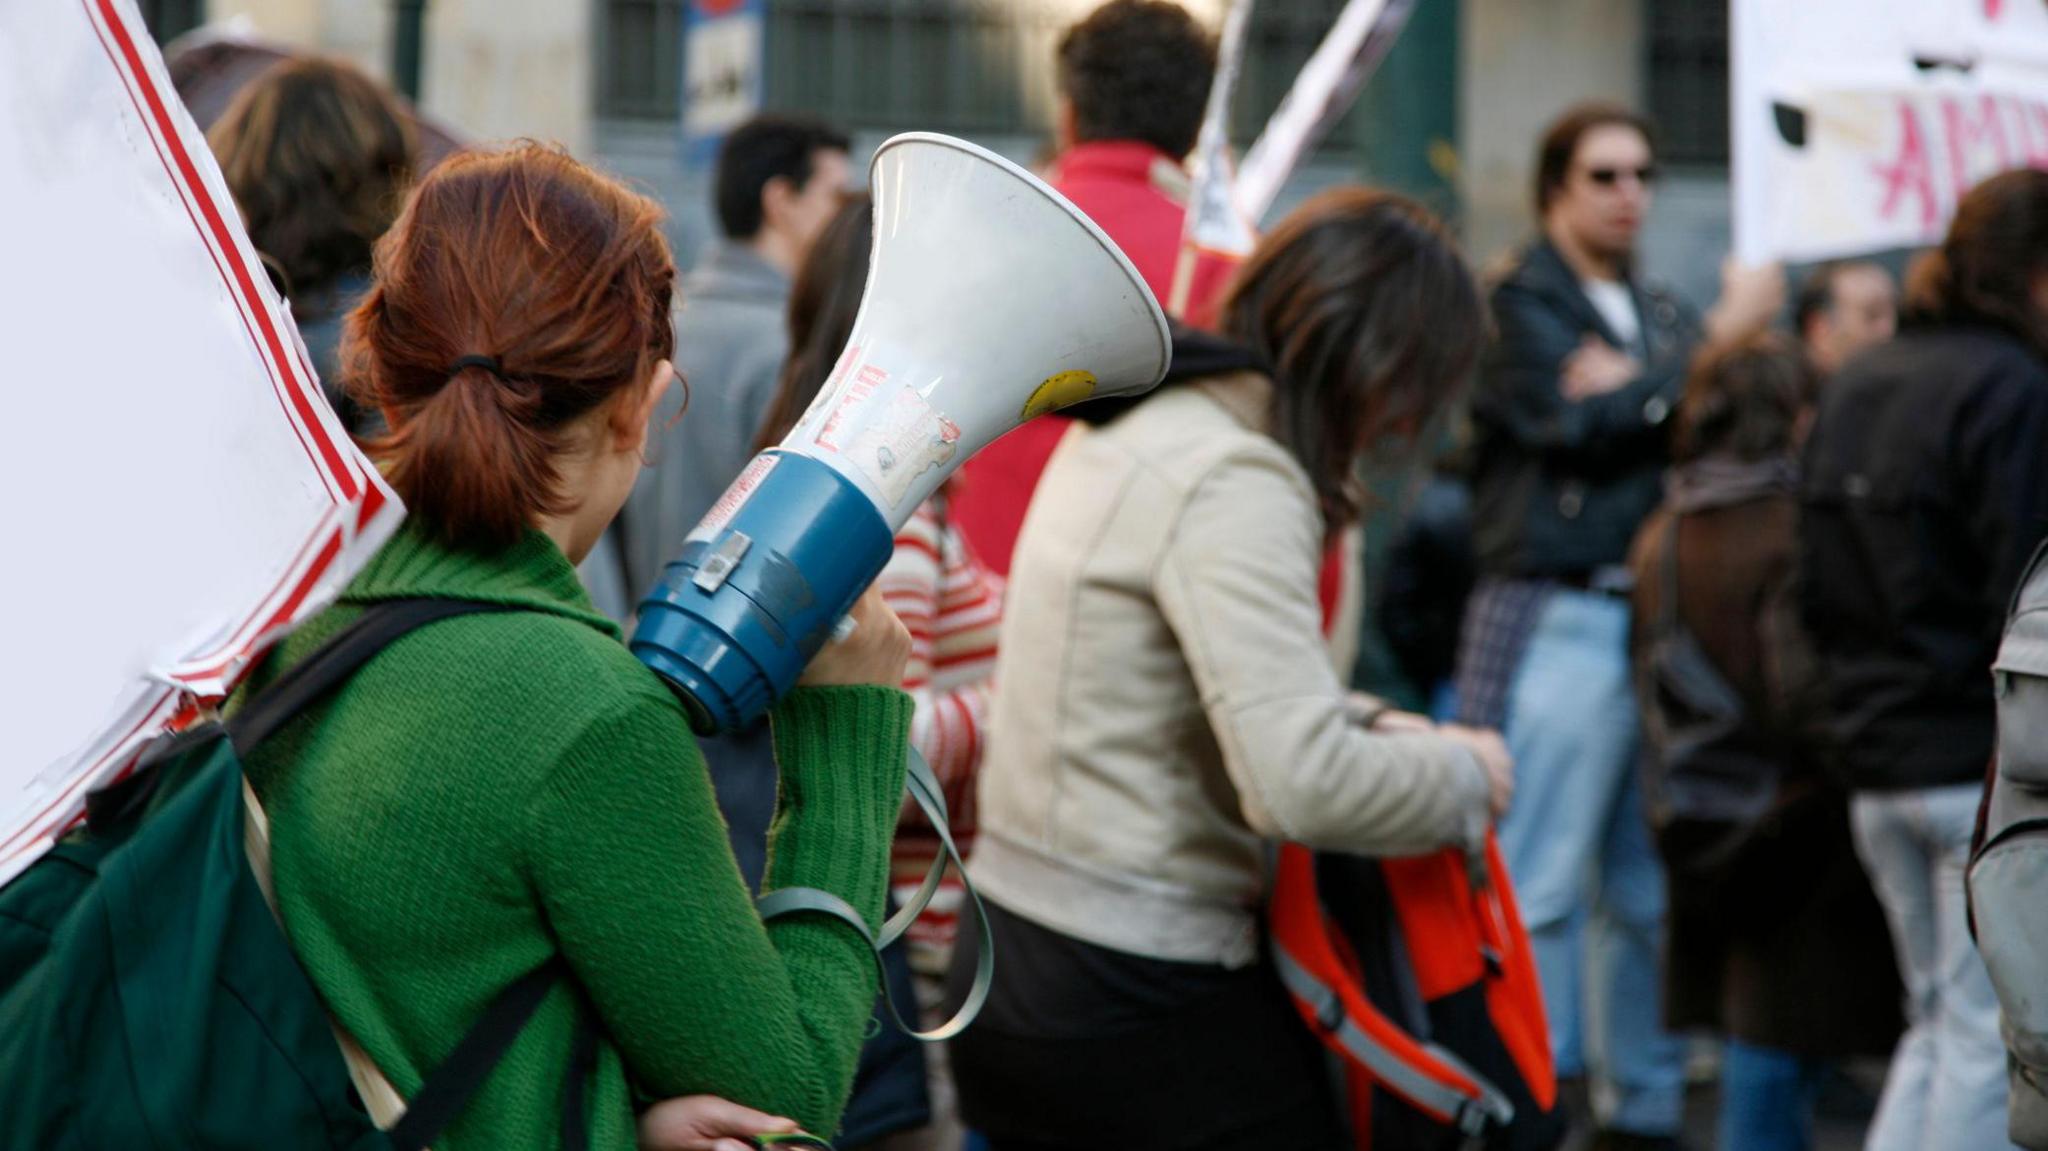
[1458,104,1784,1149]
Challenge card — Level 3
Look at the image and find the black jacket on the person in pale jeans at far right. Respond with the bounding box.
[1800,326,2048,791]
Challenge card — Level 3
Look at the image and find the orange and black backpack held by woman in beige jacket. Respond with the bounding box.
[1268,547,1565,1151]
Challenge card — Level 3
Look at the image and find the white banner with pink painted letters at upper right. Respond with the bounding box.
[1729,0,2048,264]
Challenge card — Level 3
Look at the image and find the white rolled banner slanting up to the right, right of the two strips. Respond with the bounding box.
[1237,0,1415,223]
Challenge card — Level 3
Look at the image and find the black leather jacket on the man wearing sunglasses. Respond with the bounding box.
[1473,240,1700,580]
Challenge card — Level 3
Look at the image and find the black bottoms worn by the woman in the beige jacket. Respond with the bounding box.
[948,903,1348,1151]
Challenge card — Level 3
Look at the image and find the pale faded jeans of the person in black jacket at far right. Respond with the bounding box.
[1849,782,2011,1151]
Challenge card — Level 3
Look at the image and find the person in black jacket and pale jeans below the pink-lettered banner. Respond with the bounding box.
[1800,170,2048,1151]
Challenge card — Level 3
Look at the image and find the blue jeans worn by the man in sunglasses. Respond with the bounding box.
[1499,590,1686,1135]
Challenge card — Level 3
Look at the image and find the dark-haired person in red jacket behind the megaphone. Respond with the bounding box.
[952,0,1229,573]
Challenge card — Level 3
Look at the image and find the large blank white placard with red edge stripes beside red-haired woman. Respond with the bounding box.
[0,0,403,883]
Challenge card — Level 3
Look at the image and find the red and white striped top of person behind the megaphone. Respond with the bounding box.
[877,496,1004,973]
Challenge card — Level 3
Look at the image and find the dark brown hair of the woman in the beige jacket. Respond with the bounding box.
[1223,188,1487,528]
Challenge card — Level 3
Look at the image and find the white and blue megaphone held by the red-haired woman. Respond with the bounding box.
[633,131,1169,735]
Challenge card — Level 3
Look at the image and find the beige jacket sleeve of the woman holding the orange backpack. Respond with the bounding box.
[1155,442,1487,856]
